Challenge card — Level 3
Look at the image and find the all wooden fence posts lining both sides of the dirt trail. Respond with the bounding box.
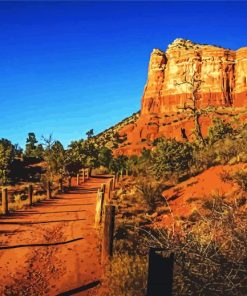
[2,169,174,296]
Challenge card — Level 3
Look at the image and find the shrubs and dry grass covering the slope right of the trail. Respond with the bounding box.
[97,118,247,295]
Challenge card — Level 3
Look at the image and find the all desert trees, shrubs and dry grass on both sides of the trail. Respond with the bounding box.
[0,117,247,296]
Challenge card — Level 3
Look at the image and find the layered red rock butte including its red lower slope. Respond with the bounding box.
[115,38,247,155]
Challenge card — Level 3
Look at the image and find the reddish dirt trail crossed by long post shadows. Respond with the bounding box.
[0,178,107,296]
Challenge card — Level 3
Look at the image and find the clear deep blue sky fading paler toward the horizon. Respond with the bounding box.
[0,1,247,146]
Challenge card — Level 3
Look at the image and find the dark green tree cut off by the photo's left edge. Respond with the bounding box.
[0,139,15,185]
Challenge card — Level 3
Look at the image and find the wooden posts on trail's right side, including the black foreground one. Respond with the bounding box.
[95,176,174,296]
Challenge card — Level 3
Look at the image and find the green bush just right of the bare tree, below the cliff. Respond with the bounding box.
[208,118,233,145]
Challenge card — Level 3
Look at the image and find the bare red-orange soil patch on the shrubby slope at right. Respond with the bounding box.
[158,164,247,227]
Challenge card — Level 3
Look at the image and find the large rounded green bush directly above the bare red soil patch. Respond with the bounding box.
[152,139,193,178]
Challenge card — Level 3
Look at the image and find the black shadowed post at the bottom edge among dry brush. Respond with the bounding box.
[146,248,174,296]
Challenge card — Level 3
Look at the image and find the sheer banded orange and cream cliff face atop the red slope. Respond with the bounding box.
[141,39,247,114]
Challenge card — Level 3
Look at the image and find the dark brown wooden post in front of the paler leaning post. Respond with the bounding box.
[101,205,115,263]
